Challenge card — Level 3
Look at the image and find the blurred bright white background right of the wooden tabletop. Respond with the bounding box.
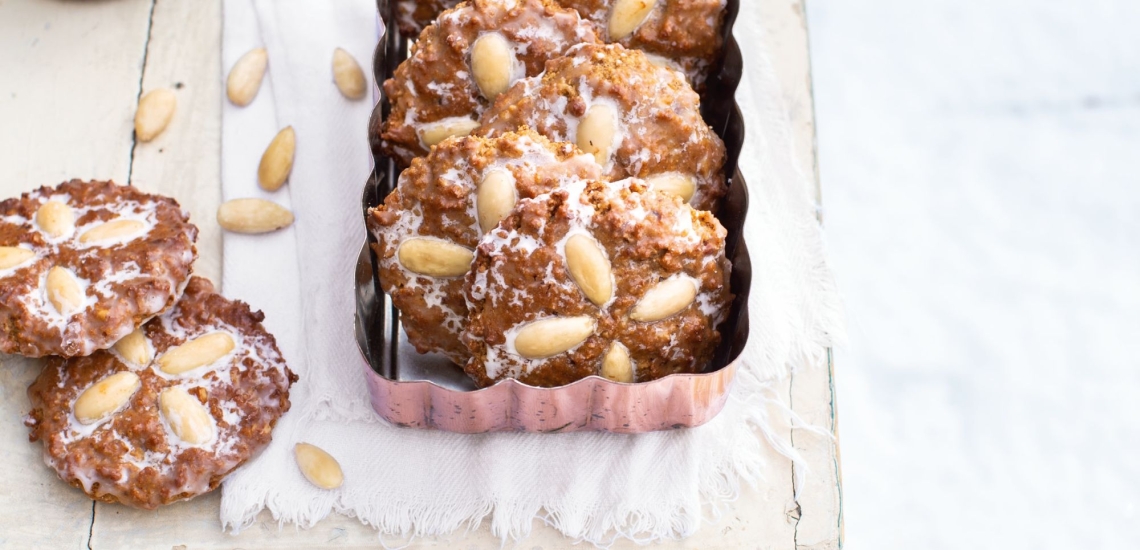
[807,0,1140,549]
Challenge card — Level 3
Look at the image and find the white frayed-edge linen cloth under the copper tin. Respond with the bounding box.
[220,0,841,543]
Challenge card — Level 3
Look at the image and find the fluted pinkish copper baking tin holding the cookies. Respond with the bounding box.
[356,0,752,434]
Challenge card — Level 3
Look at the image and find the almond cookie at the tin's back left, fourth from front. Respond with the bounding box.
[372,0,599,165]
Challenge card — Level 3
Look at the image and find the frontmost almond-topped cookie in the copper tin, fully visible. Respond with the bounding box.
[463,179,732,387]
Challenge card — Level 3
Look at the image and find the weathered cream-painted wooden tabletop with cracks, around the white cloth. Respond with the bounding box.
[0,0,842,549]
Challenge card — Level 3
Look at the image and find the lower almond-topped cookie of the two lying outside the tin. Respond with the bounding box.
[25,277,296,509]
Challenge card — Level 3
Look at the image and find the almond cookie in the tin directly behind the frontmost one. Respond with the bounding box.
[368,130,601,365]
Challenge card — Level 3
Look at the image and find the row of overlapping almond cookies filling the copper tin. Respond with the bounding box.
[368,0,732,387]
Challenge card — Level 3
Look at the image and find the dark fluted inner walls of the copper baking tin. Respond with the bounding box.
[356,0,752,397]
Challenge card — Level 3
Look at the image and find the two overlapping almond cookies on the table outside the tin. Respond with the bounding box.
[0,180,296,509]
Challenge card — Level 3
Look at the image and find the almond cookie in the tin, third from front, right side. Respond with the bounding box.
[474,45,726,211]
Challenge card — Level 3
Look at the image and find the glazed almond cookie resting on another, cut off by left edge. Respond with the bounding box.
[0,179,198,357]
